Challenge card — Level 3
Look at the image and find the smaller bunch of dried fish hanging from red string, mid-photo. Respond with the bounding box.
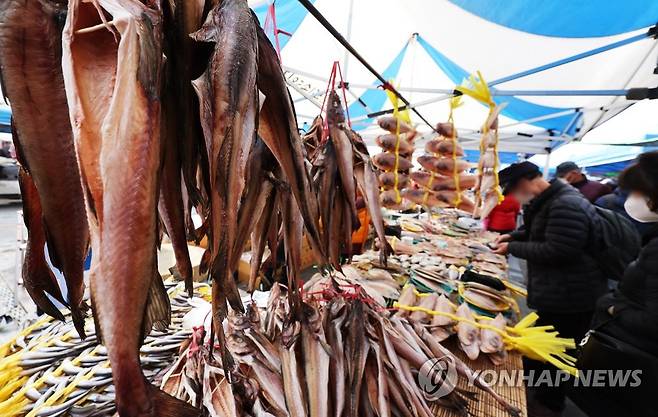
[304,90,389,270]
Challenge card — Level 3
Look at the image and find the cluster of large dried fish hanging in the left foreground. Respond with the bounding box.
[0,0,328,416]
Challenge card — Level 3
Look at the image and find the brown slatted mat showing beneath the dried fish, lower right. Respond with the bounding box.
[432,339,528,417]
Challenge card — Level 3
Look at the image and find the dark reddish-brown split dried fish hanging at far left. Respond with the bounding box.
[0,0,89,337]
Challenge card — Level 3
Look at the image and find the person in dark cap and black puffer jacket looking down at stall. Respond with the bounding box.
[494,161,607,417]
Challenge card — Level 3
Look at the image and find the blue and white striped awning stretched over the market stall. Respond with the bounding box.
[250,0,658,158]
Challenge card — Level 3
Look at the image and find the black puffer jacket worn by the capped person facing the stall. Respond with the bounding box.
[508,180,607,312]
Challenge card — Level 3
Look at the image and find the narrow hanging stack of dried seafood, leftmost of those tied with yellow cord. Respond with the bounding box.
[372,116,416,210]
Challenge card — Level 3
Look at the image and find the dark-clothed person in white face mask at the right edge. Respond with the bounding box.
[570,152,658,417]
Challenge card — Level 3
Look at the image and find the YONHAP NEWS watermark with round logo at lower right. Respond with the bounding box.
[418,357,642,400]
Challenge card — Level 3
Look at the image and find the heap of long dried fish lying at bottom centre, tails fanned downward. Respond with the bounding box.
[162,276,520,417]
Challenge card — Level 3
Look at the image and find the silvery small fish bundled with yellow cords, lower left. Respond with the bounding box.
[0,286,202,417]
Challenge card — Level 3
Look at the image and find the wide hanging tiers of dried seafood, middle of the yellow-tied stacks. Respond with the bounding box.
[405,122,476,212]
